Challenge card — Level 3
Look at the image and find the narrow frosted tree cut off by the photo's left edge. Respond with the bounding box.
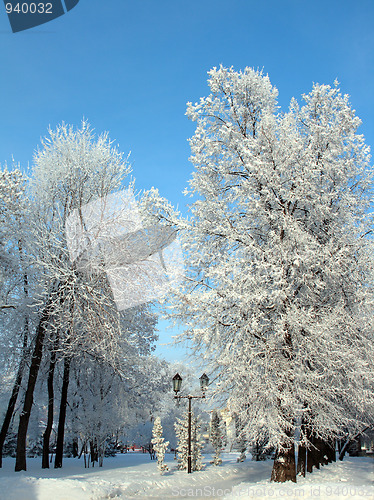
[0,166,32,467]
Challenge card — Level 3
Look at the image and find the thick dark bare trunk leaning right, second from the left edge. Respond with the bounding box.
[15,306,49,472]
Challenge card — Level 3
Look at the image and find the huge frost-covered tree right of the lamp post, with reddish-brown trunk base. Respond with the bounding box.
[159,67,374,481]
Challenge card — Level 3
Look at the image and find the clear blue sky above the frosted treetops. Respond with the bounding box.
[0,0,374,359]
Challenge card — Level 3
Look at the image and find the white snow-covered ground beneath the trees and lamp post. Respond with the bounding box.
[0,453,374,500]
